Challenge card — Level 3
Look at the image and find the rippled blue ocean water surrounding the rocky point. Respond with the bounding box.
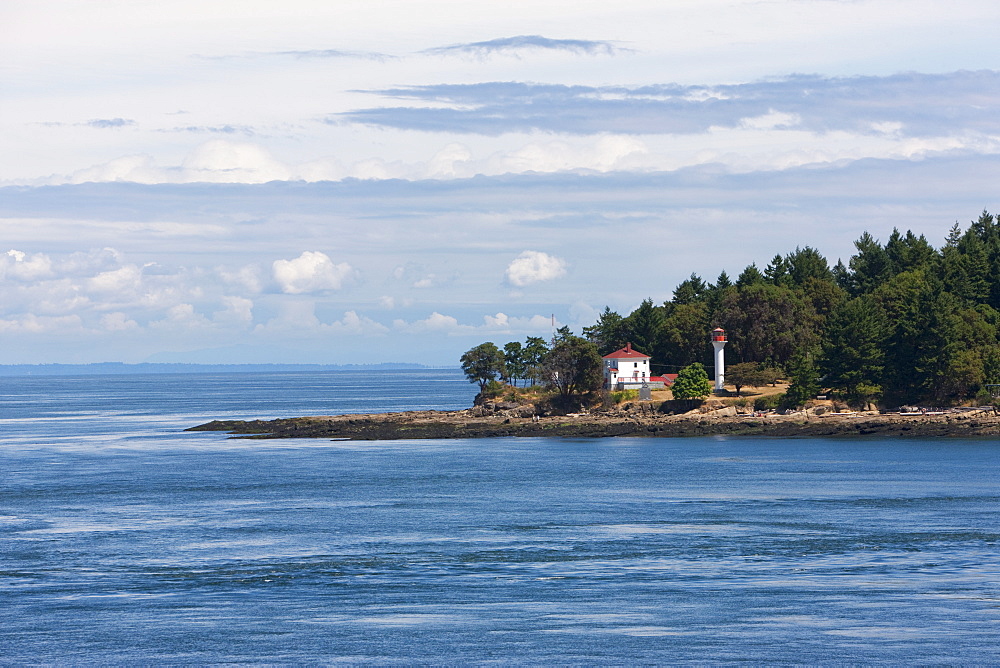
[0,371,1000,665]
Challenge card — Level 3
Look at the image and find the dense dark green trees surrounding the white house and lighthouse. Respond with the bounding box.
[463,211,1000,406]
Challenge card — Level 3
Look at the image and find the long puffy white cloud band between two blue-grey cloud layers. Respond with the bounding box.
[41,126,1000,188]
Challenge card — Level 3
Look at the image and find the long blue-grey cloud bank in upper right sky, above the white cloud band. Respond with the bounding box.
[342,71,1000,136]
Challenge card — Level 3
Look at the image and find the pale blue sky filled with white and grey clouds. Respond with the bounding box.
[0,0,1000,365]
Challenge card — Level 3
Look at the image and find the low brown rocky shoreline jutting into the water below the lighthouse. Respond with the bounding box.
[188,406,1000,441]
